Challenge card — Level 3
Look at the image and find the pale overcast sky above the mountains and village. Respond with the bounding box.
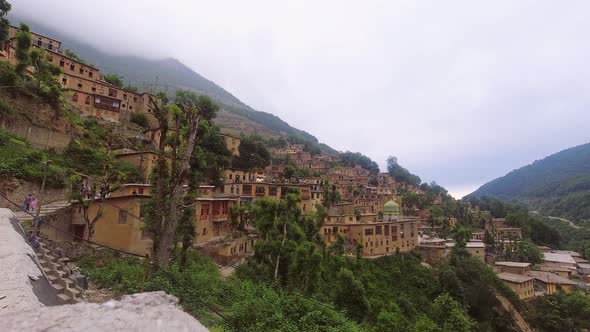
[11,0,590,196]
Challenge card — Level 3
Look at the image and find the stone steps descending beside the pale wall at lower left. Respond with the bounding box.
[37,242,83,304]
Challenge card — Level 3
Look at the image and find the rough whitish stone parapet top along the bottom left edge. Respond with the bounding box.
[0,292,208,332]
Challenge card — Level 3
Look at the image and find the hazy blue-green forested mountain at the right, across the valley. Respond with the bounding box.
[469,143,590,220]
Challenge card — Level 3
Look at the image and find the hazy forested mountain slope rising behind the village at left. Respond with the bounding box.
[10,17,335,152]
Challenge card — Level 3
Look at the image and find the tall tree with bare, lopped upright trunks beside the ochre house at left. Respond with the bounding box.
[145,90,219,264]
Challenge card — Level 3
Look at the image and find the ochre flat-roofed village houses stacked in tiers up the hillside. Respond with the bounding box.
[0,26,590,306]
